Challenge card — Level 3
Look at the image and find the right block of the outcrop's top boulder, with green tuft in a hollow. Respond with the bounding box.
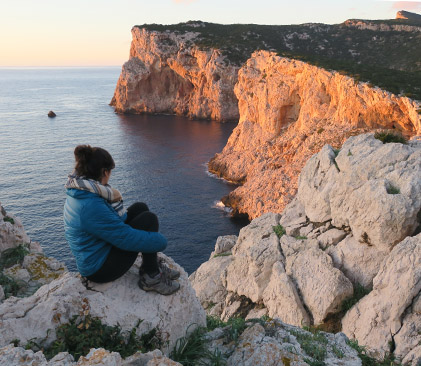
[330,135,421,251]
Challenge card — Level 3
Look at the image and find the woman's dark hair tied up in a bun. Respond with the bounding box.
[74,145,115,180]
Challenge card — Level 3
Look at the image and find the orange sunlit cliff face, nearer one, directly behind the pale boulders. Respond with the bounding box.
[209,51,421,218]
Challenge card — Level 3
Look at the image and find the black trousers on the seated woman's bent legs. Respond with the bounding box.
[87,202,159,283]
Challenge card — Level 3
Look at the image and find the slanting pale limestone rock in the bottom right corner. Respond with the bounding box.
[342,234,421,358]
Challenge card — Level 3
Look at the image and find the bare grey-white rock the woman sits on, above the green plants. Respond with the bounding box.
[0,254,205,348]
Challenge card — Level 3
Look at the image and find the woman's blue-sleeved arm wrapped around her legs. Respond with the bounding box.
[81,197,167,253]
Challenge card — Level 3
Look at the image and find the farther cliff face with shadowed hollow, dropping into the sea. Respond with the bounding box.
[111,27,238,121]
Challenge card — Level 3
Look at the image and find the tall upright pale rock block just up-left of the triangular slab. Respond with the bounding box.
[226,213,283,302]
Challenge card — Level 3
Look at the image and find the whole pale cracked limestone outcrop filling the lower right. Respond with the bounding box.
[190,134,421,366]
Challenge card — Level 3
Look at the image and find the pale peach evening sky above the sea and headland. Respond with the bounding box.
[0,0,421,67]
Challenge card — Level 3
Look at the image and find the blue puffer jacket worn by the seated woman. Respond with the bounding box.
[64,188,167,276]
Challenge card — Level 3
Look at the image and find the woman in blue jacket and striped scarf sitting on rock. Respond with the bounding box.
[64,145,180,295]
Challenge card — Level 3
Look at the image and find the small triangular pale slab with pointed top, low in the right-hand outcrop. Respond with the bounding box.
[263,262,310,326]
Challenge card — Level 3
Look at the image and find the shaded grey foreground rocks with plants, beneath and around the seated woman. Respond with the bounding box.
[0,206,368,366]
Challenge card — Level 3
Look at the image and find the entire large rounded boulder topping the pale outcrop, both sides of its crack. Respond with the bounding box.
[297,134,421,251]
